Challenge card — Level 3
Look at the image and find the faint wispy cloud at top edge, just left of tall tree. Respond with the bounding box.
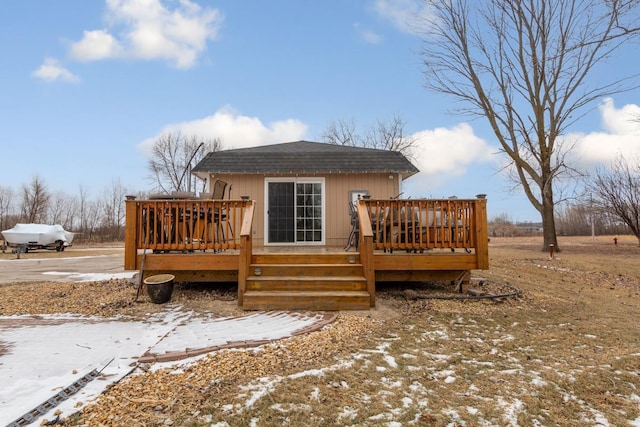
[374,0,431,34]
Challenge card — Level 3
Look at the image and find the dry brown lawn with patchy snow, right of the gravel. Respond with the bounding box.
[172,237,640,426]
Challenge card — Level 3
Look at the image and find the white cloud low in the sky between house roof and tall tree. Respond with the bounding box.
[411,123,496,192]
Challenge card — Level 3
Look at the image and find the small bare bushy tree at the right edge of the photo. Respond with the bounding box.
[589,156,640,245]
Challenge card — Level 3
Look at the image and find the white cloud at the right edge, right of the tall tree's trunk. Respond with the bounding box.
[566,98,640,169]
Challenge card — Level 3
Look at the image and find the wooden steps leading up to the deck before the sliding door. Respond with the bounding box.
[243,253,370,310]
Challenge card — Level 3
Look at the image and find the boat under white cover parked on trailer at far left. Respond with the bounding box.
[1,224,74,252]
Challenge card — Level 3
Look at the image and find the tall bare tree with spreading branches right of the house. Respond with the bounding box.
[422,0,640,250]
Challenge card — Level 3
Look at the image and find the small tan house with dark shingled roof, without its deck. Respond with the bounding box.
[193,141,418,247]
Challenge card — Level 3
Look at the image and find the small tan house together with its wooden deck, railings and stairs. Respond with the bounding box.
[124,141,489,310]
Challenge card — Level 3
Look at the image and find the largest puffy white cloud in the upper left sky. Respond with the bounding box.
[69,0,222,68]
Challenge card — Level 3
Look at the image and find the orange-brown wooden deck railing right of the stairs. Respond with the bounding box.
[360,199,487,253]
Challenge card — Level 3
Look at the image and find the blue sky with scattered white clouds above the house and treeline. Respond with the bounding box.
[0,0,640,221]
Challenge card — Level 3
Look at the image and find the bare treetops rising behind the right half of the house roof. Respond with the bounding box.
[321,116,417,157]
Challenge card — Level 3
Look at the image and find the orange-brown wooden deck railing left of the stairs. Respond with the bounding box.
[125,199,252,260]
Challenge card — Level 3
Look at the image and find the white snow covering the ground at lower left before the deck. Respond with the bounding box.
[0,275,328,425]
